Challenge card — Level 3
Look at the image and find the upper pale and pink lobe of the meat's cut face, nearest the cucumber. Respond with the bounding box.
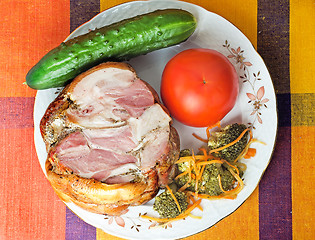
[67,63,154,128]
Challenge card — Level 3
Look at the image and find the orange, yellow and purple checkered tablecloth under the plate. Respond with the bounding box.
[0,0,315,240]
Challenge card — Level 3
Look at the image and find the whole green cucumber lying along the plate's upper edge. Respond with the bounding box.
[26,9,196,90]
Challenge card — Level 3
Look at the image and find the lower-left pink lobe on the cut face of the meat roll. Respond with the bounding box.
[54,125,137,182]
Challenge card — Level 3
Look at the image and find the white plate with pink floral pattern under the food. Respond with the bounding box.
[34,0,277,239]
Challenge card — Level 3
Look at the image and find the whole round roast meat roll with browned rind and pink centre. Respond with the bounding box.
[40,62,179,215]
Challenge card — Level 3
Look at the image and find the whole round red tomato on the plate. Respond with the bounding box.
[161,48,239,127]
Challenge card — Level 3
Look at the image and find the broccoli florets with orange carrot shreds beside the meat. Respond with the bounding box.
[142,122,264,227]
